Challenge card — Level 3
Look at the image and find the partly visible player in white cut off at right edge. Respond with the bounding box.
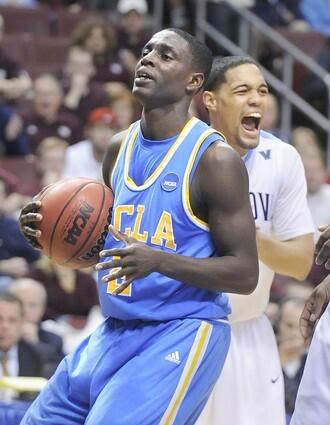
[290,225,330,425]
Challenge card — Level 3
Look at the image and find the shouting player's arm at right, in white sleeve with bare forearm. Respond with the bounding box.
[257,146,314,280]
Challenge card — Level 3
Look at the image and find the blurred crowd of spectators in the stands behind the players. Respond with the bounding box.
[0,0,330,414]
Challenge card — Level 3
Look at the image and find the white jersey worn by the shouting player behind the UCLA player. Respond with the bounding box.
[229,131,314,322]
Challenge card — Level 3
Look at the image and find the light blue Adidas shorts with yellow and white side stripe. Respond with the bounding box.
[21,319,230,425]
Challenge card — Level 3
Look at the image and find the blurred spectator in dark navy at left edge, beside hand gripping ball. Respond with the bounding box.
[0,174,39,287]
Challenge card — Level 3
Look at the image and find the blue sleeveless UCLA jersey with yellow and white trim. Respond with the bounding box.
[98,118,230,321]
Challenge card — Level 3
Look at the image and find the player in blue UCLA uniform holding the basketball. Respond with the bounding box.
[20,29,258,425]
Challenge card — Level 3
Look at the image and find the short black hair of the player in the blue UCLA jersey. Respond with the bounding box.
[167,28,212,86]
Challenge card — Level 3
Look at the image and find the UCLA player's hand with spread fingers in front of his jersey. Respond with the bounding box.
[95,225,157,295]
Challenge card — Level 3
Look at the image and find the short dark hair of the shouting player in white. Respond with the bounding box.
[204,56,261,91]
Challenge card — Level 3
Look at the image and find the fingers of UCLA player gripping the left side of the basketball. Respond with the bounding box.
[19,201,42,249]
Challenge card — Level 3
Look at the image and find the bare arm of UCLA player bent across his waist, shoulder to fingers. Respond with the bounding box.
[96,143,258,295]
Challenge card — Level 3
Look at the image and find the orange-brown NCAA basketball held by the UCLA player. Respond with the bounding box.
[35,178,113,269]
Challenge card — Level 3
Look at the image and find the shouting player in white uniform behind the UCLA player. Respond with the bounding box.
[197,56,314,425]
